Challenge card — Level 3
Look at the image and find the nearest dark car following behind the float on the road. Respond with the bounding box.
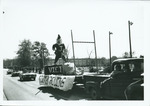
[19,72,36,81]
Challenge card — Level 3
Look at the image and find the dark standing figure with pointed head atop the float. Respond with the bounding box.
[52,34,67,64]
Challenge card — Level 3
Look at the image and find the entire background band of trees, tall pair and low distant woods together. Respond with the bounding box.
[3,39,143,69]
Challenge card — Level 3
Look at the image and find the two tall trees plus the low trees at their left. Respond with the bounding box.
[3,39,49,69]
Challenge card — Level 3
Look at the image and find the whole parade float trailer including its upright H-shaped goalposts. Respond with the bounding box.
[39,30,97,91]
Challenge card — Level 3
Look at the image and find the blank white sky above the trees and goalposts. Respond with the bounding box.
[1,0,148,59]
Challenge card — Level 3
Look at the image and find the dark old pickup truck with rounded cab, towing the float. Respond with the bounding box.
[83,58,144,100]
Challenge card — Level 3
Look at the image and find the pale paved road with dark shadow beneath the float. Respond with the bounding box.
[3,70,89,100]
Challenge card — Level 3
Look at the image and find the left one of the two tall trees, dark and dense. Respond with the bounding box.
[17,39,32,67]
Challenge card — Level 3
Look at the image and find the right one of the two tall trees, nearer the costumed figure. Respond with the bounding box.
[32,41,49,69]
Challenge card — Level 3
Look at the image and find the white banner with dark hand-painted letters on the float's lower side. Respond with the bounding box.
[39,75,75,91]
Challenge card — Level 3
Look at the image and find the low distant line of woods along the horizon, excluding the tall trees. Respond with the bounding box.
[3,56,117,69]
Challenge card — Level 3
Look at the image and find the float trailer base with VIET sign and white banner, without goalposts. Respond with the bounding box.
[39,63,83,91]
